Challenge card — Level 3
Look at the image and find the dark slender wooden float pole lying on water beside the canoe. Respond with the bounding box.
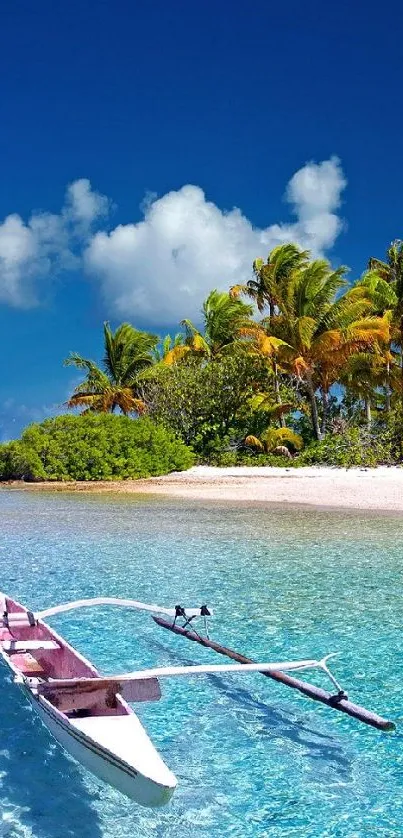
[153,615,396,731]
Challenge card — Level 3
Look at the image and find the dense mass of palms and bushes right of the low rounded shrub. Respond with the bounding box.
[139,241,403,466]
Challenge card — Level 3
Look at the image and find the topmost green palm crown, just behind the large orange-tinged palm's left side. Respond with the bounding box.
[230,248,309,317]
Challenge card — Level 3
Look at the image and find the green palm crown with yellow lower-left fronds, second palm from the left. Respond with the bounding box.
[164,290,253,364]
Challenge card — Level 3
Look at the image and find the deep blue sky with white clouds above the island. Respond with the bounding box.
[0,0,403,439]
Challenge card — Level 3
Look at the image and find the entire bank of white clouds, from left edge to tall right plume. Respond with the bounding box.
[0,157,346,318]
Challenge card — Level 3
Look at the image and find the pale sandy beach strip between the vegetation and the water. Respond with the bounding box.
[0,466,403,513]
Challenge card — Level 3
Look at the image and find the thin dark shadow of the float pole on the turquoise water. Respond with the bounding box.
[149,640,353,781]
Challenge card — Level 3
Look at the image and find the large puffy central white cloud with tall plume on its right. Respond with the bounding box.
[84,157,346,325]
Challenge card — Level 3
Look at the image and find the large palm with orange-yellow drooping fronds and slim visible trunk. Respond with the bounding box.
[263,259,389,439]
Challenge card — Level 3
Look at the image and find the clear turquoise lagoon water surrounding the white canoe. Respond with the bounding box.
[0,491,403,838]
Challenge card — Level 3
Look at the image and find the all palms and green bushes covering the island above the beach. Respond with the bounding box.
[0,240,403,508]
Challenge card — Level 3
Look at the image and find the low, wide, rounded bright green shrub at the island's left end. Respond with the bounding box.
[0,413,194,480]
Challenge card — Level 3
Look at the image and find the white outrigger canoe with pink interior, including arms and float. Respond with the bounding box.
[0,594,395,806]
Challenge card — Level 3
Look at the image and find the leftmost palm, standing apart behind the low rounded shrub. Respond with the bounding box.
[64,323,158,415]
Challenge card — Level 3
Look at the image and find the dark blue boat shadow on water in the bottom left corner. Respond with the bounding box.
[0,667,102,838]
